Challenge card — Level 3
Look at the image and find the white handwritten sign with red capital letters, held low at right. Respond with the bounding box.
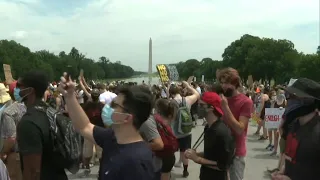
[264,108,285,129]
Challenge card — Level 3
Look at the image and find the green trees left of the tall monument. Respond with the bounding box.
[0,40,143,80]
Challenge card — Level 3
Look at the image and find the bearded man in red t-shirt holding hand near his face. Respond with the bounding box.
[217,68,253,180]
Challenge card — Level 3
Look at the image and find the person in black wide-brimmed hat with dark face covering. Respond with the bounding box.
[272,78,320,180]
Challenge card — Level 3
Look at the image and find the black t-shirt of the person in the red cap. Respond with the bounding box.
[200,120,235,180]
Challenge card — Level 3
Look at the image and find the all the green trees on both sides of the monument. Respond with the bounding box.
[0,34,320,83]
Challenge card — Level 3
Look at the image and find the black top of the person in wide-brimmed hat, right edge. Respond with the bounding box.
[285,116,320,180]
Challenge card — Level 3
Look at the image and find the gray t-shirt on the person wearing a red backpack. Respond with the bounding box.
[139,115,162,172]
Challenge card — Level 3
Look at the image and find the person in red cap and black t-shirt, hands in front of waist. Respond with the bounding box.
[185,92,235,180]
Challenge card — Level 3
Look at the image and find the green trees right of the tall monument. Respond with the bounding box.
[176,34,320,84]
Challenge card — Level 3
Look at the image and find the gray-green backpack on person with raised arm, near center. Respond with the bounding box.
[175,97,193,134]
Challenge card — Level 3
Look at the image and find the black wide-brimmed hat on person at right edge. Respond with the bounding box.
[285,78,320,100]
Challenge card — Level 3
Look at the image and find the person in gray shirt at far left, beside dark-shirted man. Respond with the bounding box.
[0,79,26,180]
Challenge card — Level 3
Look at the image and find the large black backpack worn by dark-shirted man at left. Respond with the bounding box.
[35,106,82,174]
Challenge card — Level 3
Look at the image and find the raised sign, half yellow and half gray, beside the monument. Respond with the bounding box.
[156,64,179,82]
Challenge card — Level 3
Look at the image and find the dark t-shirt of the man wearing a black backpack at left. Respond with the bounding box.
[17,103,68,180]
